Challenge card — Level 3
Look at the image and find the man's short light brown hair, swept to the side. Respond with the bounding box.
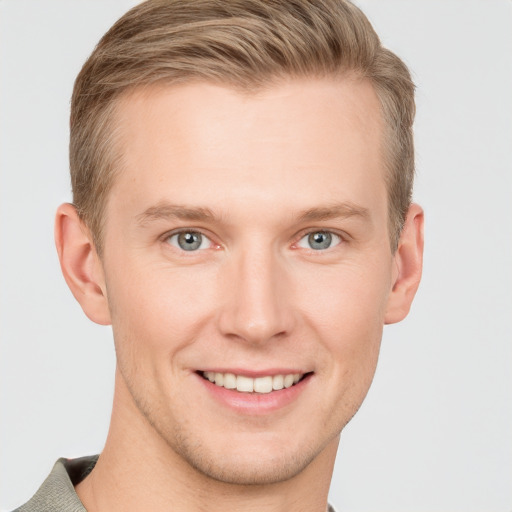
[70,0,415,254]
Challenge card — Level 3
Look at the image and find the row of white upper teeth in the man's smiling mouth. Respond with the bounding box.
[203,372,303,393]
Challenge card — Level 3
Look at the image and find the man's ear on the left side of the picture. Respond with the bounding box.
[55,203,111,325]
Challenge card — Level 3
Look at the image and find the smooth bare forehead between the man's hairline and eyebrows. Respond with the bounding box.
[108,78,385,217]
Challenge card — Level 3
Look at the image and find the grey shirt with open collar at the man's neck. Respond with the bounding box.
[13,455,335,512]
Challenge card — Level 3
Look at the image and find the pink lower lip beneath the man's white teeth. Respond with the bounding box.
[196,374,313,415]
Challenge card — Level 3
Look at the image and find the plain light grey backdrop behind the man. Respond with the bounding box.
[0,0,512,512]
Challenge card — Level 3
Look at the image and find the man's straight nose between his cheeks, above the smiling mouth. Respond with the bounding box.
[219,247,294,344]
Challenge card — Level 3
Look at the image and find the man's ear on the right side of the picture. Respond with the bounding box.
[384,204,423,324]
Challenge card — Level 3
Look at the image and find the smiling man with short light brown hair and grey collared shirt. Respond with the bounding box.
[15,0,423,511]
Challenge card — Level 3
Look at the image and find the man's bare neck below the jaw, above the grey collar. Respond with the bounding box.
[76,375,339,512]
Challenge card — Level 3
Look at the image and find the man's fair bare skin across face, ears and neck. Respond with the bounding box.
[56,78,423,511]
